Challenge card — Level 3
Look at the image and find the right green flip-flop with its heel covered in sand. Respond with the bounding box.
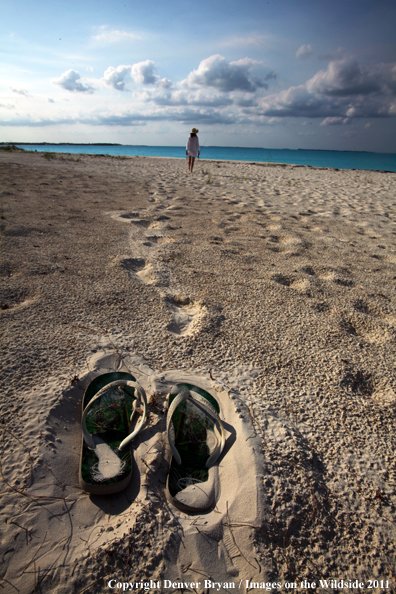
[166,384,225,513]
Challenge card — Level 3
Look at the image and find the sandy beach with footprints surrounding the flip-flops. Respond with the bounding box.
[0,151,396,594]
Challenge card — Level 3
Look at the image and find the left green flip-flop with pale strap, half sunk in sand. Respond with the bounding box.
[79,372,147,495]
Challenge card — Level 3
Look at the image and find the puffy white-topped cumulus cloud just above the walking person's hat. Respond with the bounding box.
[181,54,268,93]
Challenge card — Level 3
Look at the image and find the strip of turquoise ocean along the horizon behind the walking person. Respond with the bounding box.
[16,144,396,172]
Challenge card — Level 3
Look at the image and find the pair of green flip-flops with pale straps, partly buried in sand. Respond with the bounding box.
[80,372,225,512]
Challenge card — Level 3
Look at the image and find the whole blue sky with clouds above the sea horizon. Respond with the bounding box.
[0,0,396,153]
